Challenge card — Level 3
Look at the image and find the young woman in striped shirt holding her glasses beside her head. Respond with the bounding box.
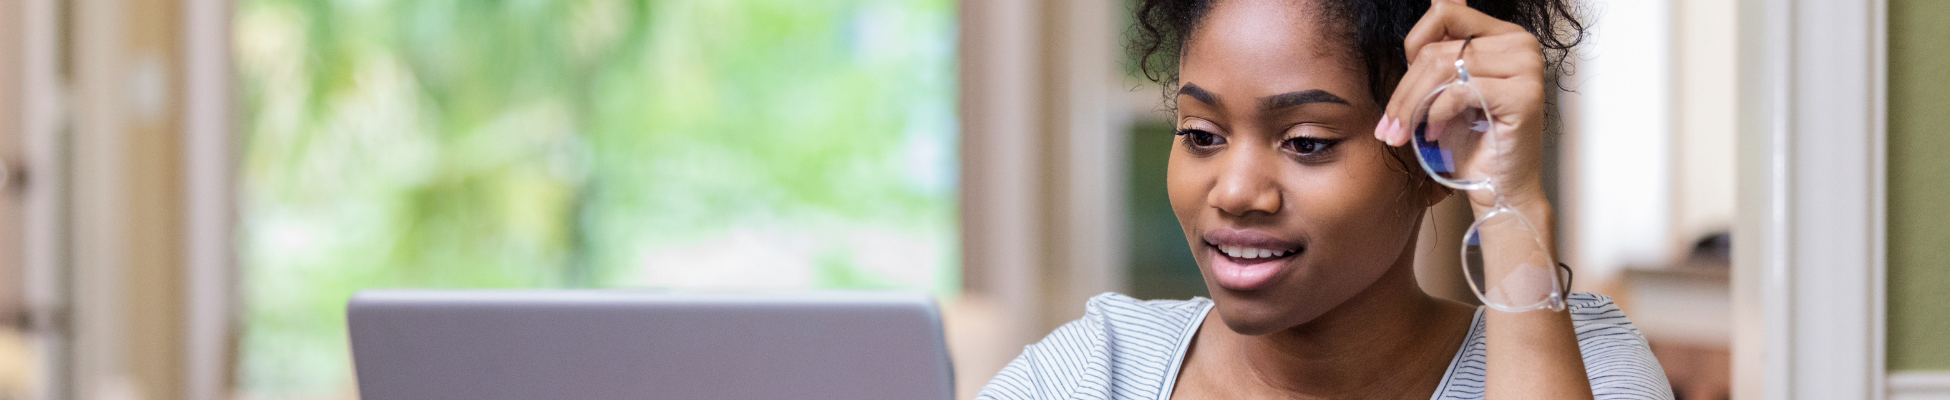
[981,0,1671,400]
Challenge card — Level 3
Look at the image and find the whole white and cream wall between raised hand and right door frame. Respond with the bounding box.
[1560,0,1736,289]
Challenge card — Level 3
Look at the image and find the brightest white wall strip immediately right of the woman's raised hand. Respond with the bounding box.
[1560,0,1673,282]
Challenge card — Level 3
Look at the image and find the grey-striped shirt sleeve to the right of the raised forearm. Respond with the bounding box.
[1570,293,1673,400]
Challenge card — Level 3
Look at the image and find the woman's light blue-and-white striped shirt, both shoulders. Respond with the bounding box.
[975,293,1673,400]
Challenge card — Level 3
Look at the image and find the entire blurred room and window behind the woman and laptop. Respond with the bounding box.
[0,0,1950,400]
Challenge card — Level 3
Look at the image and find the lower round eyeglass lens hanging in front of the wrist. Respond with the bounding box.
[1463,211,1570,310]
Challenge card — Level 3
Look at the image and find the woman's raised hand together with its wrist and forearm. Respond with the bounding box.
[1375,0,1591,400]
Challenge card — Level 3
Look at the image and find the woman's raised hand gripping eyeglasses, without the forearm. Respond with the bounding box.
[1375,0,1544,215]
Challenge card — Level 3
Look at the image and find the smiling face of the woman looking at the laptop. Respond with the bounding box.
[1166,0,1439,336]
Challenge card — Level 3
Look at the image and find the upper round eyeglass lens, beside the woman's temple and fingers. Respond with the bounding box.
[1408,82,1496,189]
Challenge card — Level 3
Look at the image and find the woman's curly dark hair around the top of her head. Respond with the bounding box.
[1127,0,1585,107]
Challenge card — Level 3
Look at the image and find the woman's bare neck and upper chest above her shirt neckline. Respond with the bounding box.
[1201,261,1474,398]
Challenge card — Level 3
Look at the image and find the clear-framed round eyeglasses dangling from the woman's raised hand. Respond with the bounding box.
[1408,37,1572,312]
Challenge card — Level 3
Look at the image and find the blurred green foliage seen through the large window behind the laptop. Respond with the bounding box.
[236,0,959,398]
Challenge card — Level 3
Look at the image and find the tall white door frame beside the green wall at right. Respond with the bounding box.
[1734,0,1888,398]
